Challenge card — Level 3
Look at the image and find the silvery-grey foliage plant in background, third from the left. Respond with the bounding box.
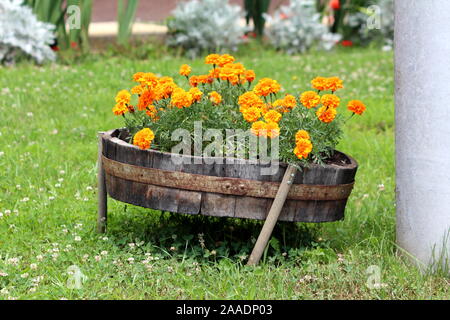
[265,0,341,54]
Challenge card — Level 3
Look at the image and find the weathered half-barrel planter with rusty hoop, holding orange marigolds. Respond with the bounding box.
[100,129,358,222]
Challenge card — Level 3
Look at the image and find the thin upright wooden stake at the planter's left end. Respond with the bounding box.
[97,132,108,233]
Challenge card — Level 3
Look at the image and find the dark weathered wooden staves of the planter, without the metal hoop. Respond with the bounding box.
[103,130,357,222]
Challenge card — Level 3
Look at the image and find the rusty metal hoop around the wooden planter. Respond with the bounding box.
[102,156,354,201]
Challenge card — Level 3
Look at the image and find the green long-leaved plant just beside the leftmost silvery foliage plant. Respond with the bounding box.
[25,0,92,51]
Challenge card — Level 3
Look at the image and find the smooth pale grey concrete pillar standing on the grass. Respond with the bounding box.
[396,0,450,271]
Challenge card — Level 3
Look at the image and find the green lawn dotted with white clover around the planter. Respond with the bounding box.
[0,45,450,299]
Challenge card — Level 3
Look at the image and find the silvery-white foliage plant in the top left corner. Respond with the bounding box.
[0,0,56,64]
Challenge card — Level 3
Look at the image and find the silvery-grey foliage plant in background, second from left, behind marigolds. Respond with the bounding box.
[167,0,247,56]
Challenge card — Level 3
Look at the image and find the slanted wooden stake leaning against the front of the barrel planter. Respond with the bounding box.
[247,165,297,266]
